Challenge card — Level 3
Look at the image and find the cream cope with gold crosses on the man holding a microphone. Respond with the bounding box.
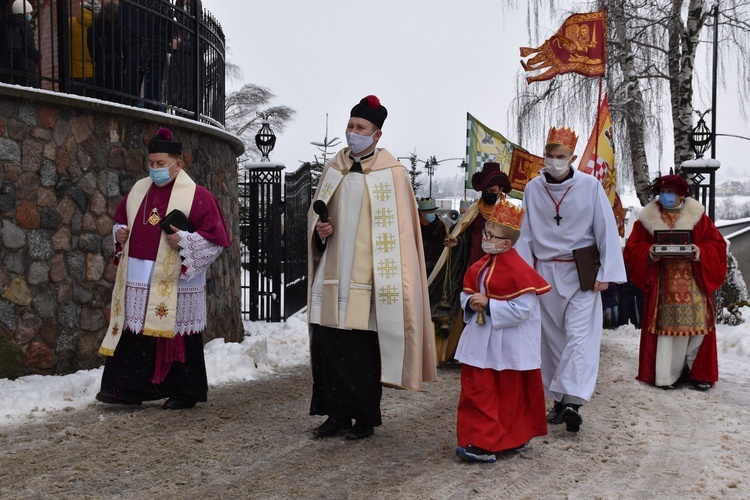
[308,148,437,390]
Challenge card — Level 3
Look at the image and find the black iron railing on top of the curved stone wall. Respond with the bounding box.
[0,0,226,126]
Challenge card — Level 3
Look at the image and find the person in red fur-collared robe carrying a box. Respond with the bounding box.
[624,175,727,391]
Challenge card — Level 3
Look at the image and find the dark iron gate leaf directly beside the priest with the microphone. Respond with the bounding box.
[284,163,312,318]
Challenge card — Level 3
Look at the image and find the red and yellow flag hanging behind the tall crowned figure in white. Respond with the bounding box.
[578,95,617,207]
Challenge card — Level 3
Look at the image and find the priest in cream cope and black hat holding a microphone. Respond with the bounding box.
[308,95,437,439]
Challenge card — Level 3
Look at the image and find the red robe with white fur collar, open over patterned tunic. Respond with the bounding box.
[625,198,727,384]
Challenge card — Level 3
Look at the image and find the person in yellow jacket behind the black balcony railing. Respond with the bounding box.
[69,0,102,97]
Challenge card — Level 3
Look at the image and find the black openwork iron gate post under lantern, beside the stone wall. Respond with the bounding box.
[238,165,284,322]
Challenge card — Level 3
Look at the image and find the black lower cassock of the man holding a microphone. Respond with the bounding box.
[310,325,383,426]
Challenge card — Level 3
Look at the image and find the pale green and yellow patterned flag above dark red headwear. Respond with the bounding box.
[466,113,523,196]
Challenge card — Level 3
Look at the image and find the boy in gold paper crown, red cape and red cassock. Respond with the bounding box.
[456,200,551,462]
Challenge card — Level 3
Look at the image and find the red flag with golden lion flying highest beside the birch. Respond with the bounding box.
[521,10,607,83]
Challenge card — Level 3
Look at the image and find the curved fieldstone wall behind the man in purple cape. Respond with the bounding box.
[0,86,243,377]
